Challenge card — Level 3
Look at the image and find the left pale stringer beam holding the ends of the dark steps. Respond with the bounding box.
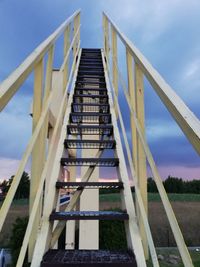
[31,49,81,267]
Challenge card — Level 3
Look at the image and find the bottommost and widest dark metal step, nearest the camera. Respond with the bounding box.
[41,249,137,267]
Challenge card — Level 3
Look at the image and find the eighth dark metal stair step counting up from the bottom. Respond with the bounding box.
[72,103,110,113]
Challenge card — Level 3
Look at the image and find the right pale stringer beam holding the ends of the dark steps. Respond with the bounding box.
[102,51,146,267]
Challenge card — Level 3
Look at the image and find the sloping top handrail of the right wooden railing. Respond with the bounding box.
[103,12,200,154]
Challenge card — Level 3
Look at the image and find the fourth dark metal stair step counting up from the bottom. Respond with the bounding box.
[60,158,119,167]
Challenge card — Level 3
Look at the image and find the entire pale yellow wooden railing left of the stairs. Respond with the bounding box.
[0,10,80,266]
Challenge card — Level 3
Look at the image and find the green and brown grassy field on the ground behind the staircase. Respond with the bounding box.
[0,193,200,267]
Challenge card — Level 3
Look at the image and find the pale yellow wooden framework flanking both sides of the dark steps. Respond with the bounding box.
[0,10,200,267]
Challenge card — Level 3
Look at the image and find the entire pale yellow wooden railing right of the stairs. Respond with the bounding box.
[103,13,200,267]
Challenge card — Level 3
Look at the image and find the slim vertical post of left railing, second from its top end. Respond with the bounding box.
[63,24,70,92]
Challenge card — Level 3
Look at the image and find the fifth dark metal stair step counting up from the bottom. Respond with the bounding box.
[64,139,116,149]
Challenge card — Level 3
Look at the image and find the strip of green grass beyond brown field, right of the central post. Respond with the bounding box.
[100,193,200,202]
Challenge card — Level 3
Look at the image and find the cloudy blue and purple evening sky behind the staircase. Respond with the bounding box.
[0,0,200,182]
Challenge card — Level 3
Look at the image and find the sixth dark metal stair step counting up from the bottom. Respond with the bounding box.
[67,125,113,136]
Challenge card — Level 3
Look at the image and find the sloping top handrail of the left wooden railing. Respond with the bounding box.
[0,10,80,111]
